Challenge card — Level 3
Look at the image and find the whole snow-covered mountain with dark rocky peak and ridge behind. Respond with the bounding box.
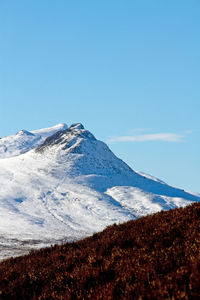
[0,123,200,257]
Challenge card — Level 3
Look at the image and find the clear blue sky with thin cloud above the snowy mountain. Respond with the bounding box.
[0,0,200,192]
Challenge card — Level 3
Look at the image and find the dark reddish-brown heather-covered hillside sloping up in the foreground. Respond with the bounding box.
[0,203,200,299]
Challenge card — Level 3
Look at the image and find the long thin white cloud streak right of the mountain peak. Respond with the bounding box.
[107,133,184,143]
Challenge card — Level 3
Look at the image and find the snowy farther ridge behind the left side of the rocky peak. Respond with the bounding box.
[0,124,67,159]
